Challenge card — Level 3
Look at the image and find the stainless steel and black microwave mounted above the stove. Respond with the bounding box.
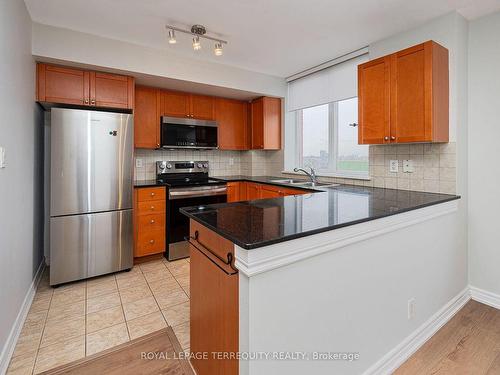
[160,116,218,149]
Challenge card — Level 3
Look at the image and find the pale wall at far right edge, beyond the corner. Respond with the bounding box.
[468,12,500,295]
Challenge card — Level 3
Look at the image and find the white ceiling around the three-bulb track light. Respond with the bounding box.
[25,0,500,77]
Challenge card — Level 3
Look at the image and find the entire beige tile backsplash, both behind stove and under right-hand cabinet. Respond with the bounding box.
[135,142,457,194]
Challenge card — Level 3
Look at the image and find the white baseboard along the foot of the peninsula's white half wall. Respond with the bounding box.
[363,287,471,375]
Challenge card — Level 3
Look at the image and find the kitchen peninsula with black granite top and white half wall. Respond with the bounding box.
[182,180,460,375]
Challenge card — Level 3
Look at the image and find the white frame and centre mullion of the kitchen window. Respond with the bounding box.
[295,96,370,180]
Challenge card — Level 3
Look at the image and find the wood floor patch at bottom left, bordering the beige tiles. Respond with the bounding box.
[37,327,194,375]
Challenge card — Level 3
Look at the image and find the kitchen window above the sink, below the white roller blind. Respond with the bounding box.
[296,98,368,177]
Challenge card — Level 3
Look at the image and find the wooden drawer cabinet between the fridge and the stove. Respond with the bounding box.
[134,187,167,258]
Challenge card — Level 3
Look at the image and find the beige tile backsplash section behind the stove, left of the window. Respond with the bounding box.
[134,149,282,180]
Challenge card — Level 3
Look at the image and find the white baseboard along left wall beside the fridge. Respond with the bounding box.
[0,260,45,374]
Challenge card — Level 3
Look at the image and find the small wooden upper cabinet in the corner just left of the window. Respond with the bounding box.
[251,97,281,150]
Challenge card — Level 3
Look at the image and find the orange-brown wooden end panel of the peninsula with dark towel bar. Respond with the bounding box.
[189,220,239,375]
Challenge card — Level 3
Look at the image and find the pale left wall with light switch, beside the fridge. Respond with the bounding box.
[0,0,43,372]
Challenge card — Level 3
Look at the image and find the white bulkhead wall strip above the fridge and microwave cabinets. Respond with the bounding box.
[33,23,286,97]
